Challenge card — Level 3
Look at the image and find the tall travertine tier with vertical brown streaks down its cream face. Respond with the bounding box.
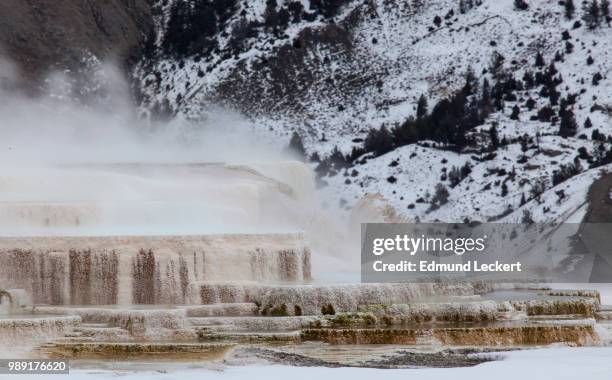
[0,234,310,305]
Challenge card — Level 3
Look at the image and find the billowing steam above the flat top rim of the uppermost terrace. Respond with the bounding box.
[0,60,282,163]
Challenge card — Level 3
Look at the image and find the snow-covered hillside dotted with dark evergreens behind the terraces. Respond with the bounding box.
[133,0,612,221]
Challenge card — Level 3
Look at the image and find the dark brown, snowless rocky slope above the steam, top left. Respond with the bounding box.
[0,0,153,88]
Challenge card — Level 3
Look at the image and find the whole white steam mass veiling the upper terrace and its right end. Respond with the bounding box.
[0,58,358,280]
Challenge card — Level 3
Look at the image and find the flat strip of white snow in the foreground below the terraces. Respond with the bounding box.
[0,347,612,380]
